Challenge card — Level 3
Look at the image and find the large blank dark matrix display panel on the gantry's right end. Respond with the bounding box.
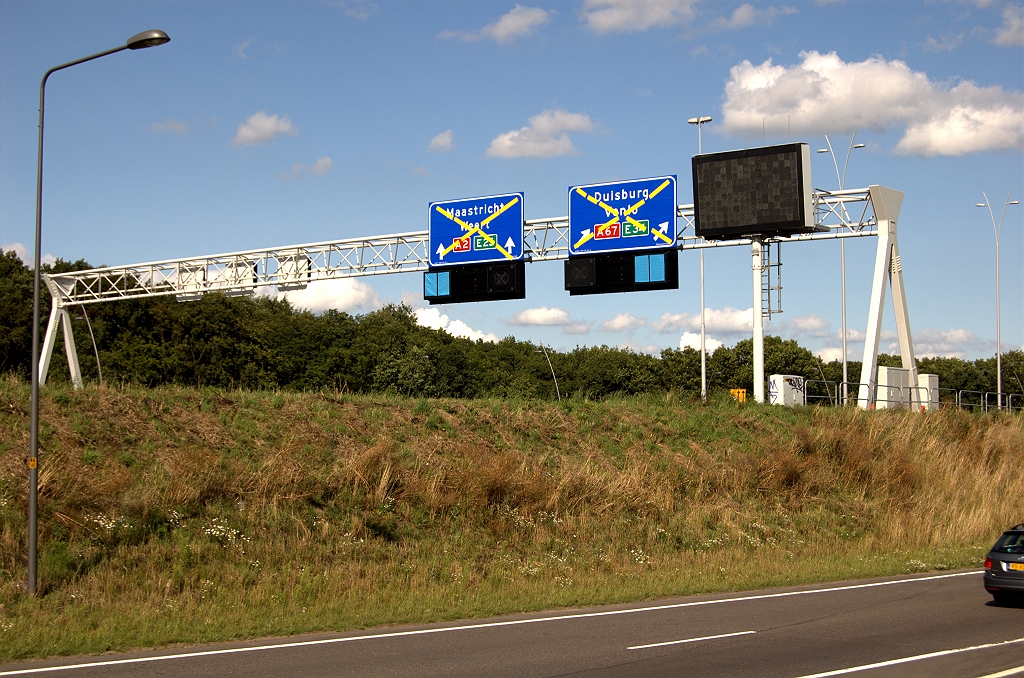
[693,143,815,240]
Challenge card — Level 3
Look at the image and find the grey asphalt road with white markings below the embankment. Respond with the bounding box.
[0,571,1024,678]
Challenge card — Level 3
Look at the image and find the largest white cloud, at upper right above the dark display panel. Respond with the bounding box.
[722,51,1024,157]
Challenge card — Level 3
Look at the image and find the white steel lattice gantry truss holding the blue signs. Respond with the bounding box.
[39,186,902,409]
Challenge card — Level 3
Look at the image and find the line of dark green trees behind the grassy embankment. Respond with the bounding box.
[0,252,1024,398]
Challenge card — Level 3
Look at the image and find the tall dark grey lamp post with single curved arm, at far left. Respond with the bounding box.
[28,31,171,595]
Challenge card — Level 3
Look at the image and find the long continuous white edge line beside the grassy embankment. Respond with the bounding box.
[0,569,984,676]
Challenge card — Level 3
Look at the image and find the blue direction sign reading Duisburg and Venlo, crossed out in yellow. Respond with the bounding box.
[569,176,676,256]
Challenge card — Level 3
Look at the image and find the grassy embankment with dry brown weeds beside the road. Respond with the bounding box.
[0,380,1024,660]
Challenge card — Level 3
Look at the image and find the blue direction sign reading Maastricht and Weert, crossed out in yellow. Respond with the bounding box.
[428,193,525,266]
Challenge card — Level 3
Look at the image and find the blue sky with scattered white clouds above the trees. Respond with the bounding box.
[0,0,1024,360]
